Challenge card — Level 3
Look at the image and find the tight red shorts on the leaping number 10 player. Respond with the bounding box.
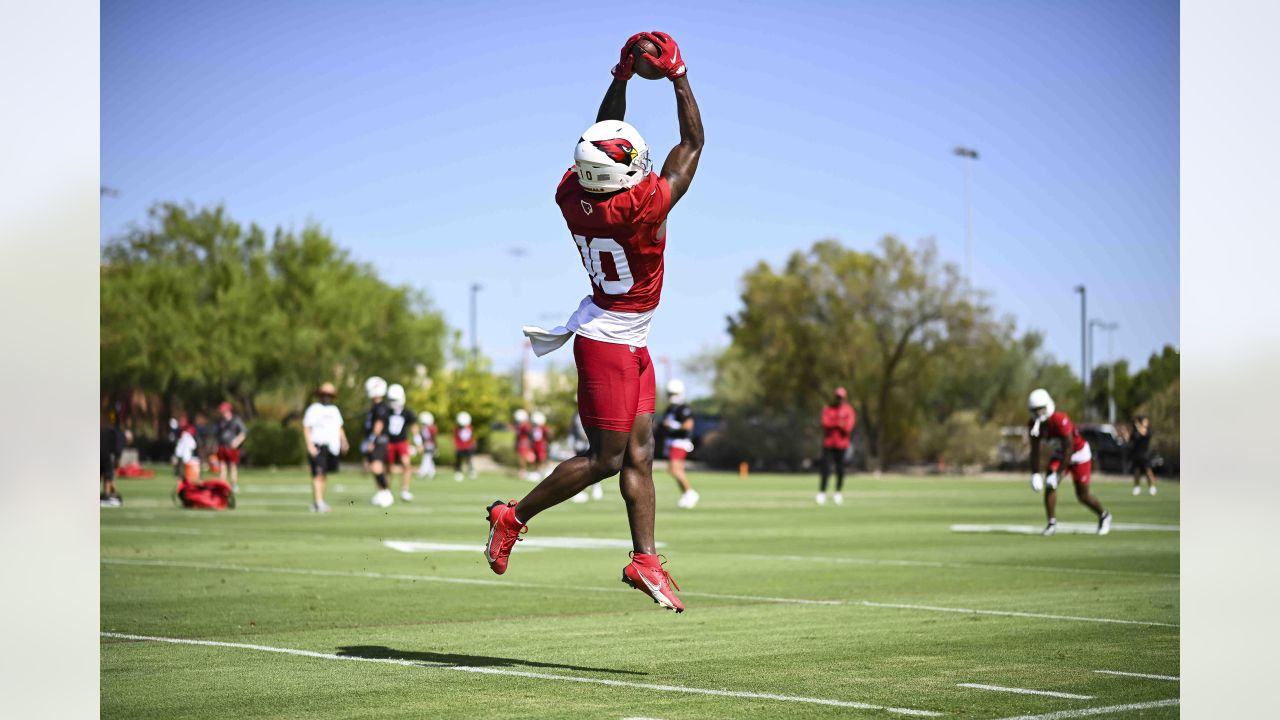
[573,336,658,433]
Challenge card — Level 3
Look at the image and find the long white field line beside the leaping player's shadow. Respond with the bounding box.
[100,632,942,717]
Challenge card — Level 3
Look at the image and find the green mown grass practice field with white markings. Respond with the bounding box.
[101,466,1179,720]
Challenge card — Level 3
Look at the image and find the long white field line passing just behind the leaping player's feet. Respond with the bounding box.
[102,557,1178,628]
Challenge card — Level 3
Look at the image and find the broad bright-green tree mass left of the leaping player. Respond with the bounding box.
[100,202,447,421]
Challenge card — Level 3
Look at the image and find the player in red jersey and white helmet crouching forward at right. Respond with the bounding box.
[1027,388,1111,536]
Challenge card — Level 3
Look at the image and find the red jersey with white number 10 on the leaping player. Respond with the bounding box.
[556,168,671,313]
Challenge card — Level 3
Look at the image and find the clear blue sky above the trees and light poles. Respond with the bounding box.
[101,0,1179,392]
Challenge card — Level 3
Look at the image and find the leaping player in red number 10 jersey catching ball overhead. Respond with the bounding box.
[484,32,703,612]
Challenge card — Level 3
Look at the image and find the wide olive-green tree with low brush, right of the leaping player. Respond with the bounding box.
[709,237,1080,468]
